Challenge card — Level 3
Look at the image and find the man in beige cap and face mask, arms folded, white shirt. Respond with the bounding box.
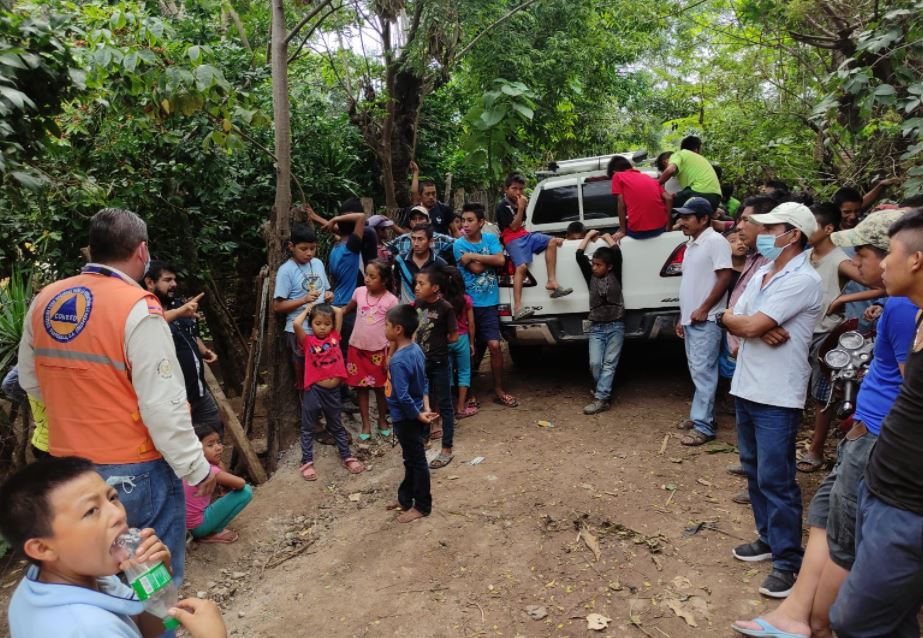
[718,202,823,598]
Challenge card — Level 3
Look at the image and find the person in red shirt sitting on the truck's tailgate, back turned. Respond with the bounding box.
[606,155,673,242]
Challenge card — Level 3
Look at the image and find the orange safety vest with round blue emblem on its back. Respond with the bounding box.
[32,268,163,464]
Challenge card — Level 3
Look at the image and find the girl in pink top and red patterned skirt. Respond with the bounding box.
[343,259,398,445]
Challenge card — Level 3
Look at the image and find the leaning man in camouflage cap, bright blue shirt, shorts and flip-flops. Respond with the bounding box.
[733,211,917,636]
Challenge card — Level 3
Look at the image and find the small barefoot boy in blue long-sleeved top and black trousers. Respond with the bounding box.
[385,304,436,523]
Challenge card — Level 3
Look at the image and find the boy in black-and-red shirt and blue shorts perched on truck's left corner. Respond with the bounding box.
[496,173,574,321]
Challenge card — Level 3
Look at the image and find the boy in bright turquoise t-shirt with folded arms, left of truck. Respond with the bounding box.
[453,203,519,408]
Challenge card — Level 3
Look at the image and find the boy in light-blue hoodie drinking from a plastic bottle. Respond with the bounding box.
[0,456,227,638]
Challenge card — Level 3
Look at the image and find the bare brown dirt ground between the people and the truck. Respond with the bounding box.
[0,342,832,638]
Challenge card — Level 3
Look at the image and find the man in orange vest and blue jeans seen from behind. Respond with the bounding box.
[19,208,215,583]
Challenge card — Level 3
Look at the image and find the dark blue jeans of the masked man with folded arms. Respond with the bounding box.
[737,397,804,571]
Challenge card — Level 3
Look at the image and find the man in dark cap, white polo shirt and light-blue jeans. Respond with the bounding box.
[675,197,733,446]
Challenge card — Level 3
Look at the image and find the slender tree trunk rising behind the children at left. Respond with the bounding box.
[266,0,298,478]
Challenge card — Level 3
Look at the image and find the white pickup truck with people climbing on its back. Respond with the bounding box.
[500,153,686,365]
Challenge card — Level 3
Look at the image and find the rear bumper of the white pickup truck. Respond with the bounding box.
[500,308,679,346]
